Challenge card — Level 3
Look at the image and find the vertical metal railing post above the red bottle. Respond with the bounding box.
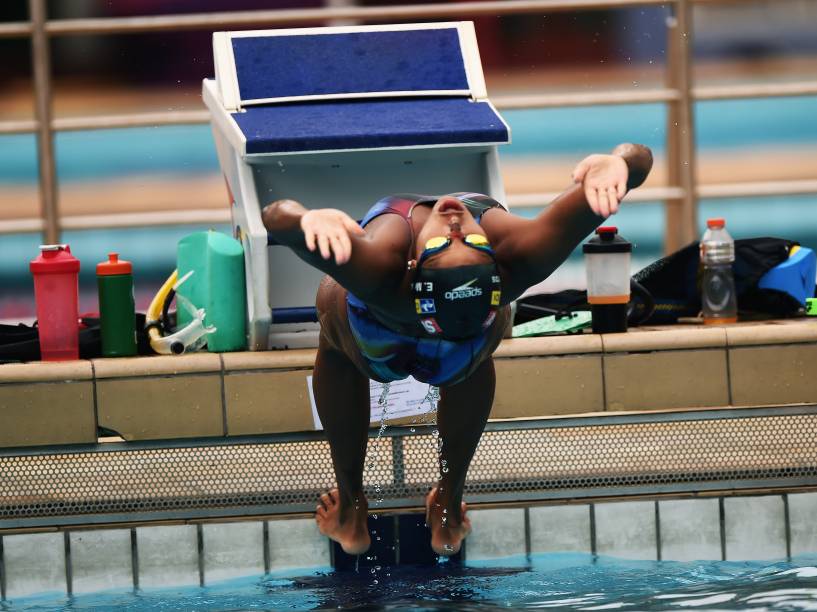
[28,0,60,244]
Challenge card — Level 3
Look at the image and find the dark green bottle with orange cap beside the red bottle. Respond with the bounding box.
[96,253,136,357]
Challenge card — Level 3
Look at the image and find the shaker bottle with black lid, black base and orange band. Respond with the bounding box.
[582,226,633,334]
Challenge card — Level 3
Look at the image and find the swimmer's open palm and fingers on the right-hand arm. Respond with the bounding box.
[573,155,629,219]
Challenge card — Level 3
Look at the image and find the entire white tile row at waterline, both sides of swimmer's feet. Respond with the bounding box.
[0,492,817,600]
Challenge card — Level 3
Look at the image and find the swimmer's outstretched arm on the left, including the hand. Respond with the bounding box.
[261,200,408,301]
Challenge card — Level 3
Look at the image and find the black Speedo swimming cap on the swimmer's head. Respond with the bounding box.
[412,263,501,340]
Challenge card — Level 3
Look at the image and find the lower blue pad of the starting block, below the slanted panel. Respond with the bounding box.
[232,98,508,155]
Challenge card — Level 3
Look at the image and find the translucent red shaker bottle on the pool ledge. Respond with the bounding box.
[29,244,79,361]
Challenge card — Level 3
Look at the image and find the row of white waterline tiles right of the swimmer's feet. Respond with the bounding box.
[466,493,817,561]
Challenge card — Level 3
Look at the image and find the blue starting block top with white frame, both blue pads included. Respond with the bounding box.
[214,22,510,155]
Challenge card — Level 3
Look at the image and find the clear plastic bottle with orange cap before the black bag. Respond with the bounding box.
[701,218,738,325]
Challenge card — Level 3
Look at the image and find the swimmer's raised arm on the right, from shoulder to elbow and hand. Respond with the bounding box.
[482,144,652,303]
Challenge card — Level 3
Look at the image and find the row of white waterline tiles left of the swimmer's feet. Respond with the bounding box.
[0,518,331,600]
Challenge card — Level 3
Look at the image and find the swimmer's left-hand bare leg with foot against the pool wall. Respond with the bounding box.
[312,336,371,555]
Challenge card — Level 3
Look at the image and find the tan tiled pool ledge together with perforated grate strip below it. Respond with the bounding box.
[0,319,817,529]
